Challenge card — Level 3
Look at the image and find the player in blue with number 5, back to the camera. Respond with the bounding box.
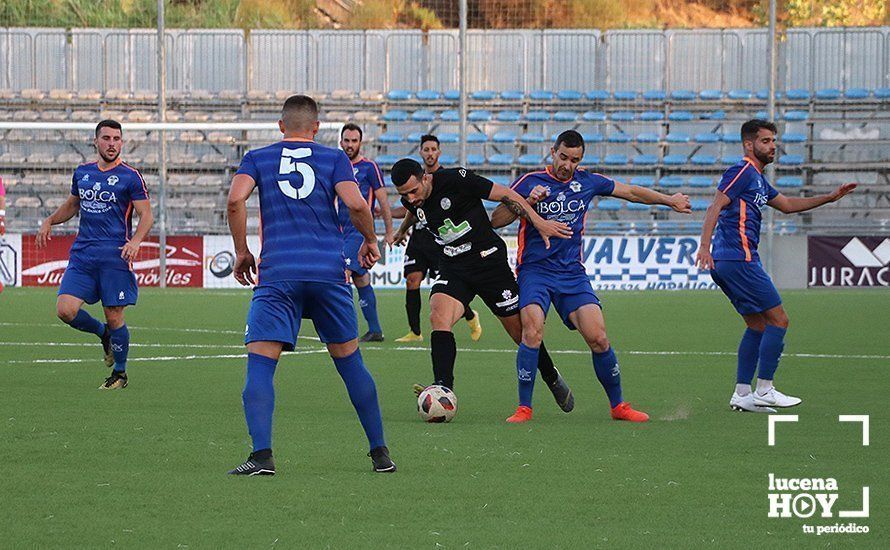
[228,95,396,476]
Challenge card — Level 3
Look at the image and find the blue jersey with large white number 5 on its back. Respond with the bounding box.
[237,141,355,283]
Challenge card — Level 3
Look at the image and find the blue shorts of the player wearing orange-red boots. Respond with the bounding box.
[518,267,602,330]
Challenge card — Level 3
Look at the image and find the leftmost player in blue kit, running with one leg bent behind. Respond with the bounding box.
[37,120,154,390]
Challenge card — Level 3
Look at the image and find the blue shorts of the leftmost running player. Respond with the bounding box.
[59,245,139,307]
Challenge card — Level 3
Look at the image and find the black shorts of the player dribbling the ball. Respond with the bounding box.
[430,244,519,317]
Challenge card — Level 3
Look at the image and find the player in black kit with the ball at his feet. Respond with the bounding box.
[392,159,574,412]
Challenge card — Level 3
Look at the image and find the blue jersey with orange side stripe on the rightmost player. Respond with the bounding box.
[711,157,779,262]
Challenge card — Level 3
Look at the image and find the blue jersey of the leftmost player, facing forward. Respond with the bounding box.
[71,162,148,250]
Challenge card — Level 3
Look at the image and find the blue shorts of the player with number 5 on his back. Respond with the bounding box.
[244,281,358,351]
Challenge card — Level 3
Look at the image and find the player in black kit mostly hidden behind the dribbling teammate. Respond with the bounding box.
[393,134,482,342]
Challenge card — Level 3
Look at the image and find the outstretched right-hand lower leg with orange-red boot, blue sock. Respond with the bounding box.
[569,304,649,422]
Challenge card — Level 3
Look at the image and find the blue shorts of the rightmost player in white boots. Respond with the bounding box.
[711,260,782,315]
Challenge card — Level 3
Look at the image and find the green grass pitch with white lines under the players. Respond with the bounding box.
[0,288,890,548]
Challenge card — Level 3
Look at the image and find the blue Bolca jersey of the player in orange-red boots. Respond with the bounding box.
[511,167,615,272]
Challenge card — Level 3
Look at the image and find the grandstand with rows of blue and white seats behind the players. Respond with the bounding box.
[0,29,890,234]
